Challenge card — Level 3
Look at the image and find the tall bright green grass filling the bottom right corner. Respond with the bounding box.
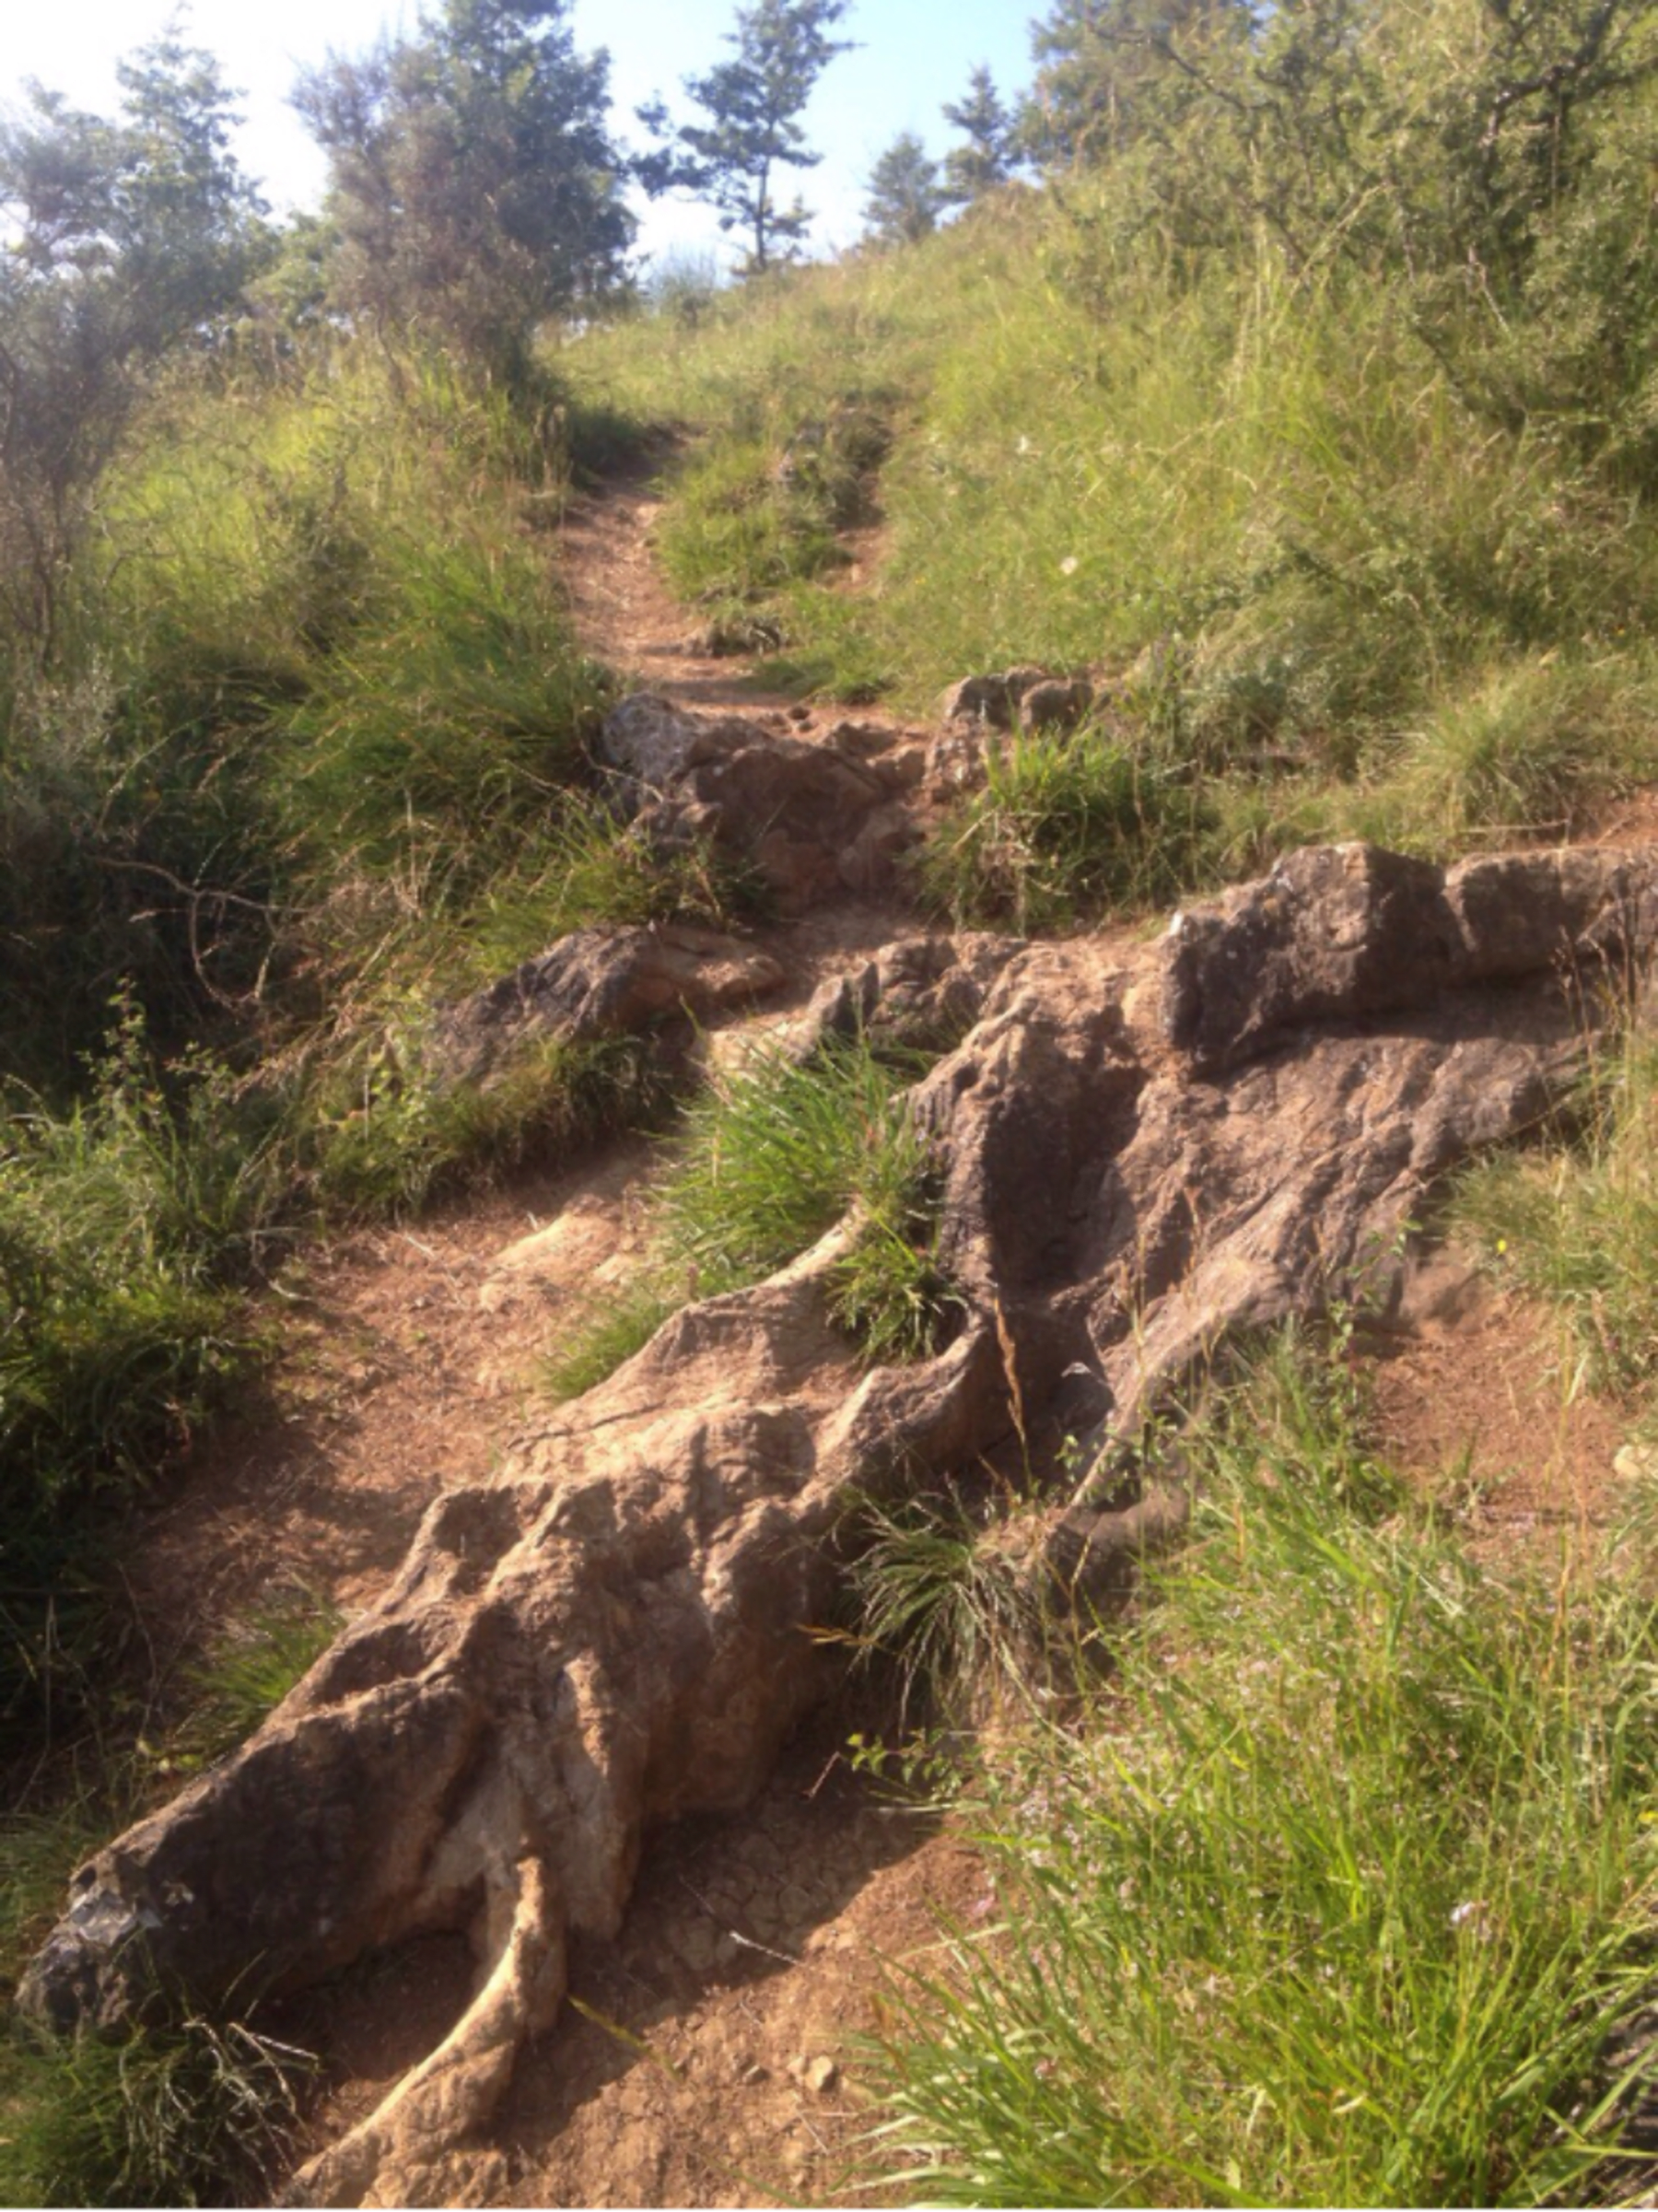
[867,1347,1658,2207]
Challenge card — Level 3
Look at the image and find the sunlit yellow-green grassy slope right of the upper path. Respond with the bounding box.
[559,188,1658,911]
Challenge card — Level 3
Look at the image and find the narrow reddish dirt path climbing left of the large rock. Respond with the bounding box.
[133,464,916,1645]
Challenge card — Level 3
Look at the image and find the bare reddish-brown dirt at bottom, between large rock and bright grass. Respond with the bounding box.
[496,1723,986,2212]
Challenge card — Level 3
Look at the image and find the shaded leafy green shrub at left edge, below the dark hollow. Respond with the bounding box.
[0,1006,283,1726]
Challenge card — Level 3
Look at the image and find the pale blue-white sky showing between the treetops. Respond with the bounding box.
[0,0,1044,267]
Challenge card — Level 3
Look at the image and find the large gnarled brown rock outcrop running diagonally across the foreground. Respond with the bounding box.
[22,848,1658,2207]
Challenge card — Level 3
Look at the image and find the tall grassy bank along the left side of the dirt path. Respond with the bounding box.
[0,343,720,1726]
